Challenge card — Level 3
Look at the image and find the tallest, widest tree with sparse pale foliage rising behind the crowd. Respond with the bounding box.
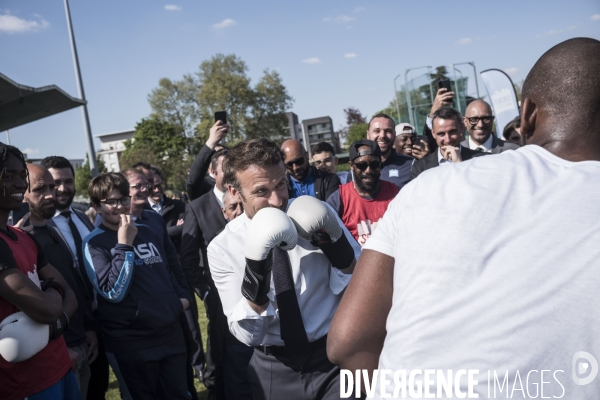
[148,54,293,147]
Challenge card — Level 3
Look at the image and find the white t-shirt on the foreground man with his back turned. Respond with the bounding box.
[363,145,600,400]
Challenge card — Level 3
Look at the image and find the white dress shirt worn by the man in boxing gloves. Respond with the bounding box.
[208,201,360,346]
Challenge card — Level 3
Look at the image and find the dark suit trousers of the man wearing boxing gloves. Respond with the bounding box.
[248,347,346,400]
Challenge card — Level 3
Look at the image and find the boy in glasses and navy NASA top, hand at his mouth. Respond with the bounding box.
[83,173,190,399]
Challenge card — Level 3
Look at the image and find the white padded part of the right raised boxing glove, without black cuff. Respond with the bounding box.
[287,196,342,242]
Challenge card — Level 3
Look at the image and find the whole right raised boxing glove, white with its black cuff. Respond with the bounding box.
[287,196,354,269]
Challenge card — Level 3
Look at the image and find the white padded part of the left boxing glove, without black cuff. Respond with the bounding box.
[244,207,298,261]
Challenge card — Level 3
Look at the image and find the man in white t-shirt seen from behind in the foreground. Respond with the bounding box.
[327,38,600,400]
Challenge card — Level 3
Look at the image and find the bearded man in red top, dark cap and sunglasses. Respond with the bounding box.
[327,140,399,246]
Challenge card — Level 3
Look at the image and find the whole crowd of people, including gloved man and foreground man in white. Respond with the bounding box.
[0,39,600,400]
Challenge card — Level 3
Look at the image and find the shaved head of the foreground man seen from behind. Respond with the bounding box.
[521,38,600,156]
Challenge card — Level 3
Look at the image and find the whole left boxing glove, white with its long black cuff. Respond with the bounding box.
[242,207,298,306]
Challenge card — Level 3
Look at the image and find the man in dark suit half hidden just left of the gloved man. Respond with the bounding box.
[180,149,253,399]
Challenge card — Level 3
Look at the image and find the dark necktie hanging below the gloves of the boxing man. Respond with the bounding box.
[273,247,311,368]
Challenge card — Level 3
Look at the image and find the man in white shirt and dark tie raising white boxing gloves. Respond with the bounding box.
[209,138,360,400]
